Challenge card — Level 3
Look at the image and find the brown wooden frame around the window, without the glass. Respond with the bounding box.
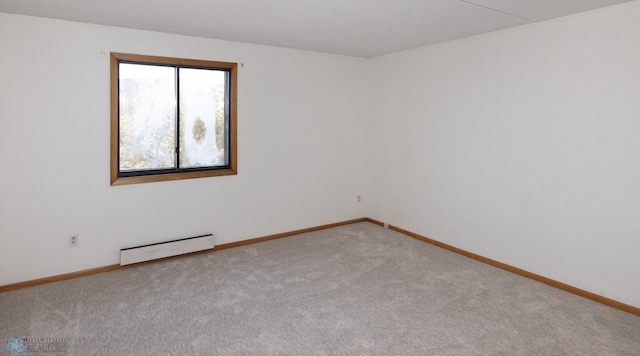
[110,52,238,186]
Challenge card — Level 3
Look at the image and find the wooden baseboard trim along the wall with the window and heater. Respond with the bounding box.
[0,218,368,293]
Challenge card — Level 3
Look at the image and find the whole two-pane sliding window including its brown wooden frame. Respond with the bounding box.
[111,53,237,185]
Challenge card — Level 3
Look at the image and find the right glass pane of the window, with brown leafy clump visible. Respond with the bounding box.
[179,68,228,168]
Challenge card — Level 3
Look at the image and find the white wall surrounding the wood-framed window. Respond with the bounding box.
[0,13,366,285]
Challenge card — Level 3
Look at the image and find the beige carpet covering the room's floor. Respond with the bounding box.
[0,223,640,356]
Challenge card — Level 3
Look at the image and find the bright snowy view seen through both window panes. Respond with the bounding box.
[119,63,228,172]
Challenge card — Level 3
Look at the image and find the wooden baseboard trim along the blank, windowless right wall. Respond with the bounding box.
[366,218,640,316]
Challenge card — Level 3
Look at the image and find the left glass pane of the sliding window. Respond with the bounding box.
[119,63,176,171]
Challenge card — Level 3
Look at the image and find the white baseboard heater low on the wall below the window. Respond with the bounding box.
[120,234,215,266]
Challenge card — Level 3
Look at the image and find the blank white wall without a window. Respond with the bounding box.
[369,1,640,307]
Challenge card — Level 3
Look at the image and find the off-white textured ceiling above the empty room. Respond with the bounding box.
[0,0,630,57]
